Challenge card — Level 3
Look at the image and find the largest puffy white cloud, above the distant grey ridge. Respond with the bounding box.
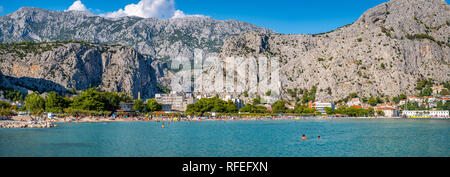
[101,0,205,18]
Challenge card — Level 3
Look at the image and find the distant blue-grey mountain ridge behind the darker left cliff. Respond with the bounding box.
[0,7,273,59]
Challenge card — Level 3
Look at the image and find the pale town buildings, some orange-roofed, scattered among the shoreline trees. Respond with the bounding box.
[153,92,450,118]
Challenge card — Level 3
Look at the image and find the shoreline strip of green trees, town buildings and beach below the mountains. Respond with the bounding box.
[0,80,450,128]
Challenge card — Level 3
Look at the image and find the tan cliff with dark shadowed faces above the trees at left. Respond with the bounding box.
[0,43,157,98]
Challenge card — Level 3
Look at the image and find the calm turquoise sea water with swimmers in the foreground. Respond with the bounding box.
[0,119,450,157]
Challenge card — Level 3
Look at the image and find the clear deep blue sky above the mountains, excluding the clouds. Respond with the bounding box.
[0,0,418,34]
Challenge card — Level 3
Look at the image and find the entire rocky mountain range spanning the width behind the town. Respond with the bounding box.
[0,0,450,101]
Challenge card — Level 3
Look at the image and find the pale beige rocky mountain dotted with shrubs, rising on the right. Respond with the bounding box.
[204,0,450,101]
